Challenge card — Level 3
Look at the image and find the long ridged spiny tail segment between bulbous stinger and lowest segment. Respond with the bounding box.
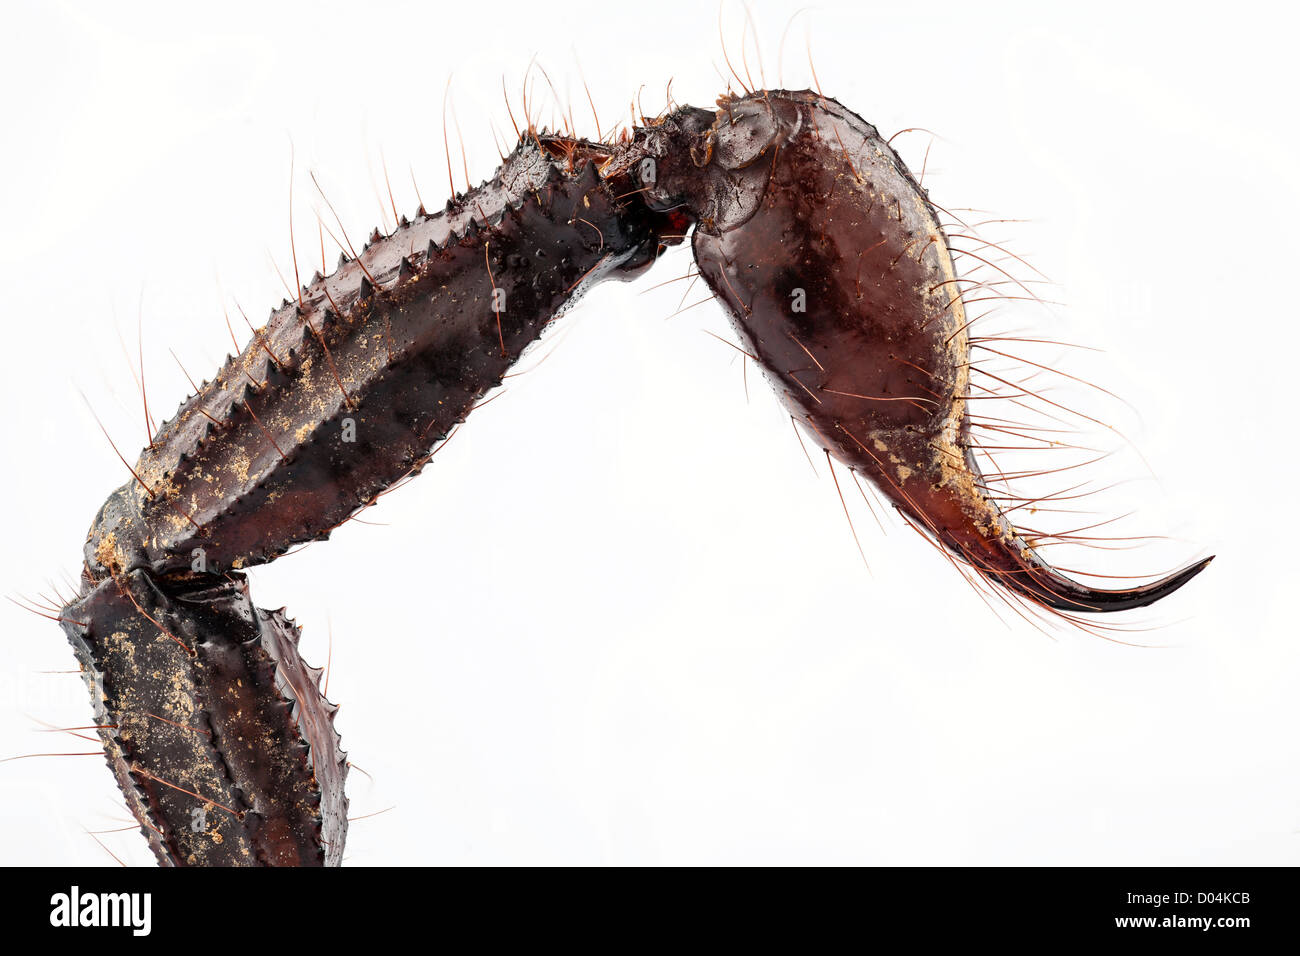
[86,140,657,576]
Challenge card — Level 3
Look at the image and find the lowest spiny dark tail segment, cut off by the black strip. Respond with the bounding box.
[64,571,347,866]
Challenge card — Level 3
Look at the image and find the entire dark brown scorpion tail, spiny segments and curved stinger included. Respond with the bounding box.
[50,91,1206,865]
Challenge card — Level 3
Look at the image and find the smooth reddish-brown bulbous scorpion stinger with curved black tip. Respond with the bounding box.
[624,91,1210,613]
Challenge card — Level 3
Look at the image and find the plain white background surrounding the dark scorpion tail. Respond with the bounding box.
[0,0,1300,865]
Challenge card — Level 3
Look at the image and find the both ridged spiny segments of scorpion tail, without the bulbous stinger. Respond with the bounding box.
[61,137,662,865]
